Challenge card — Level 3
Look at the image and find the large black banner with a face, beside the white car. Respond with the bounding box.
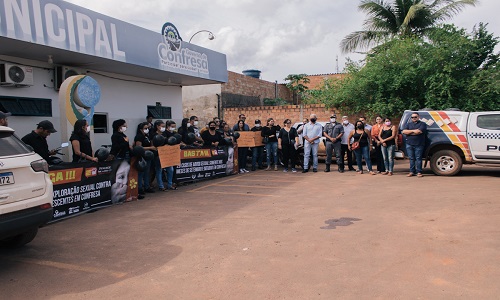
[49,159,138,221]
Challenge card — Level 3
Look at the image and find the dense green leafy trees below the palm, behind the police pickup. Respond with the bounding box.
[309,24,500,116]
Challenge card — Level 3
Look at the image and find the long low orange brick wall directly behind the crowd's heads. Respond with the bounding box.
[224,104,346,127]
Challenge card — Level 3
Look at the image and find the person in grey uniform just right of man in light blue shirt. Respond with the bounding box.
[323,115,344,173]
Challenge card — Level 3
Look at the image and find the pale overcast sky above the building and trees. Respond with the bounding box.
[67,0,500,82]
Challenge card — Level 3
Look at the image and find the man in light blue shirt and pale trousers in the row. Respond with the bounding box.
[302,114,323,173]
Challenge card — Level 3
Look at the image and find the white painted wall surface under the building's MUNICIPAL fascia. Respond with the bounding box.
[0,57,182,154]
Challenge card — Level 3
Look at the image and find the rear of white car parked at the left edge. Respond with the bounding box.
[0,126,53,247]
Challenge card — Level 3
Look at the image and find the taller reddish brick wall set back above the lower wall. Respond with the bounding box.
[221,72,292,102]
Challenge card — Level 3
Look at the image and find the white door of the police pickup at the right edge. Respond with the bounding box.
[467,111,500,163]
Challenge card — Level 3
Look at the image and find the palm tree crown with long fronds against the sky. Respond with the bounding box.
[340,0,479,53]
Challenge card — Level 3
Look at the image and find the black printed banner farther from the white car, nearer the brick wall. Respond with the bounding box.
[176,147,234,182]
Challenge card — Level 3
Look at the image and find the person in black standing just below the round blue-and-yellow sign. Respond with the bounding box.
[69,120,97,163]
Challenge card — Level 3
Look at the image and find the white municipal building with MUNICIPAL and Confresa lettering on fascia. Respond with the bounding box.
[0,0,227,154]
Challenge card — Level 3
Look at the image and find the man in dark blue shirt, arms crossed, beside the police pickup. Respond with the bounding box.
[402,112,427,177]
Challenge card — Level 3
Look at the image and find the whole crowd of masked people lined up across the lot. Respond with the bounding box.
[0,112,427,199]
